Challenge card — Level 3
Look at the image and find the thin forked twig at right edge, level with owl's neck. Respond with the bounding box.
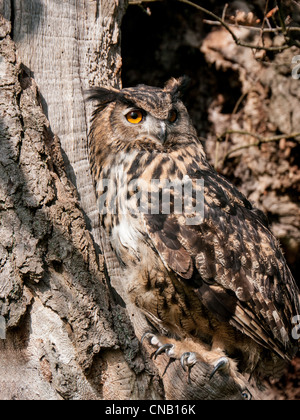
[218,130,300,166]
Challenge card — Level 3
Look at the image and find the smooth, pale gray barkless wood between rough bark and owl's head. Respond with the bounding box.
[12,0,125,243]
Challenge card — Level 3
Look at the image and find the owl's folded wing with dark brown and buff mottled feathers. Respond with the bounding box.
[143,170,300,358]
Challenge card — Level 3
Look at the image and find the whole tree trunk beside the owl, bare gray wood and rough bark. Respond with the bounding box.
[0,0,255,399]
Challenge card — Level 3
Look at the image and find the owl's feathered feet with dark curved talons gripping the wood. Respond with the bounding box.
[141,333,240,384]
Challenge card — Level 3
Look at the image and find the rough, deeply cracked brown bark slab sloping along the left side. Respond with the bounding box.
[0,37,113,399]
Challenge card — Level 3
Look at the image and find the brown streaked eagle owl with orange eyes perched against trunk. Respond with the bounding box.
[89,78,300,395]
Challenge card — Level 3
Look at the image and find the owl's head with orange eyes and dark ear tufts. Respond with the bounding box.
[89,78,197,156]
